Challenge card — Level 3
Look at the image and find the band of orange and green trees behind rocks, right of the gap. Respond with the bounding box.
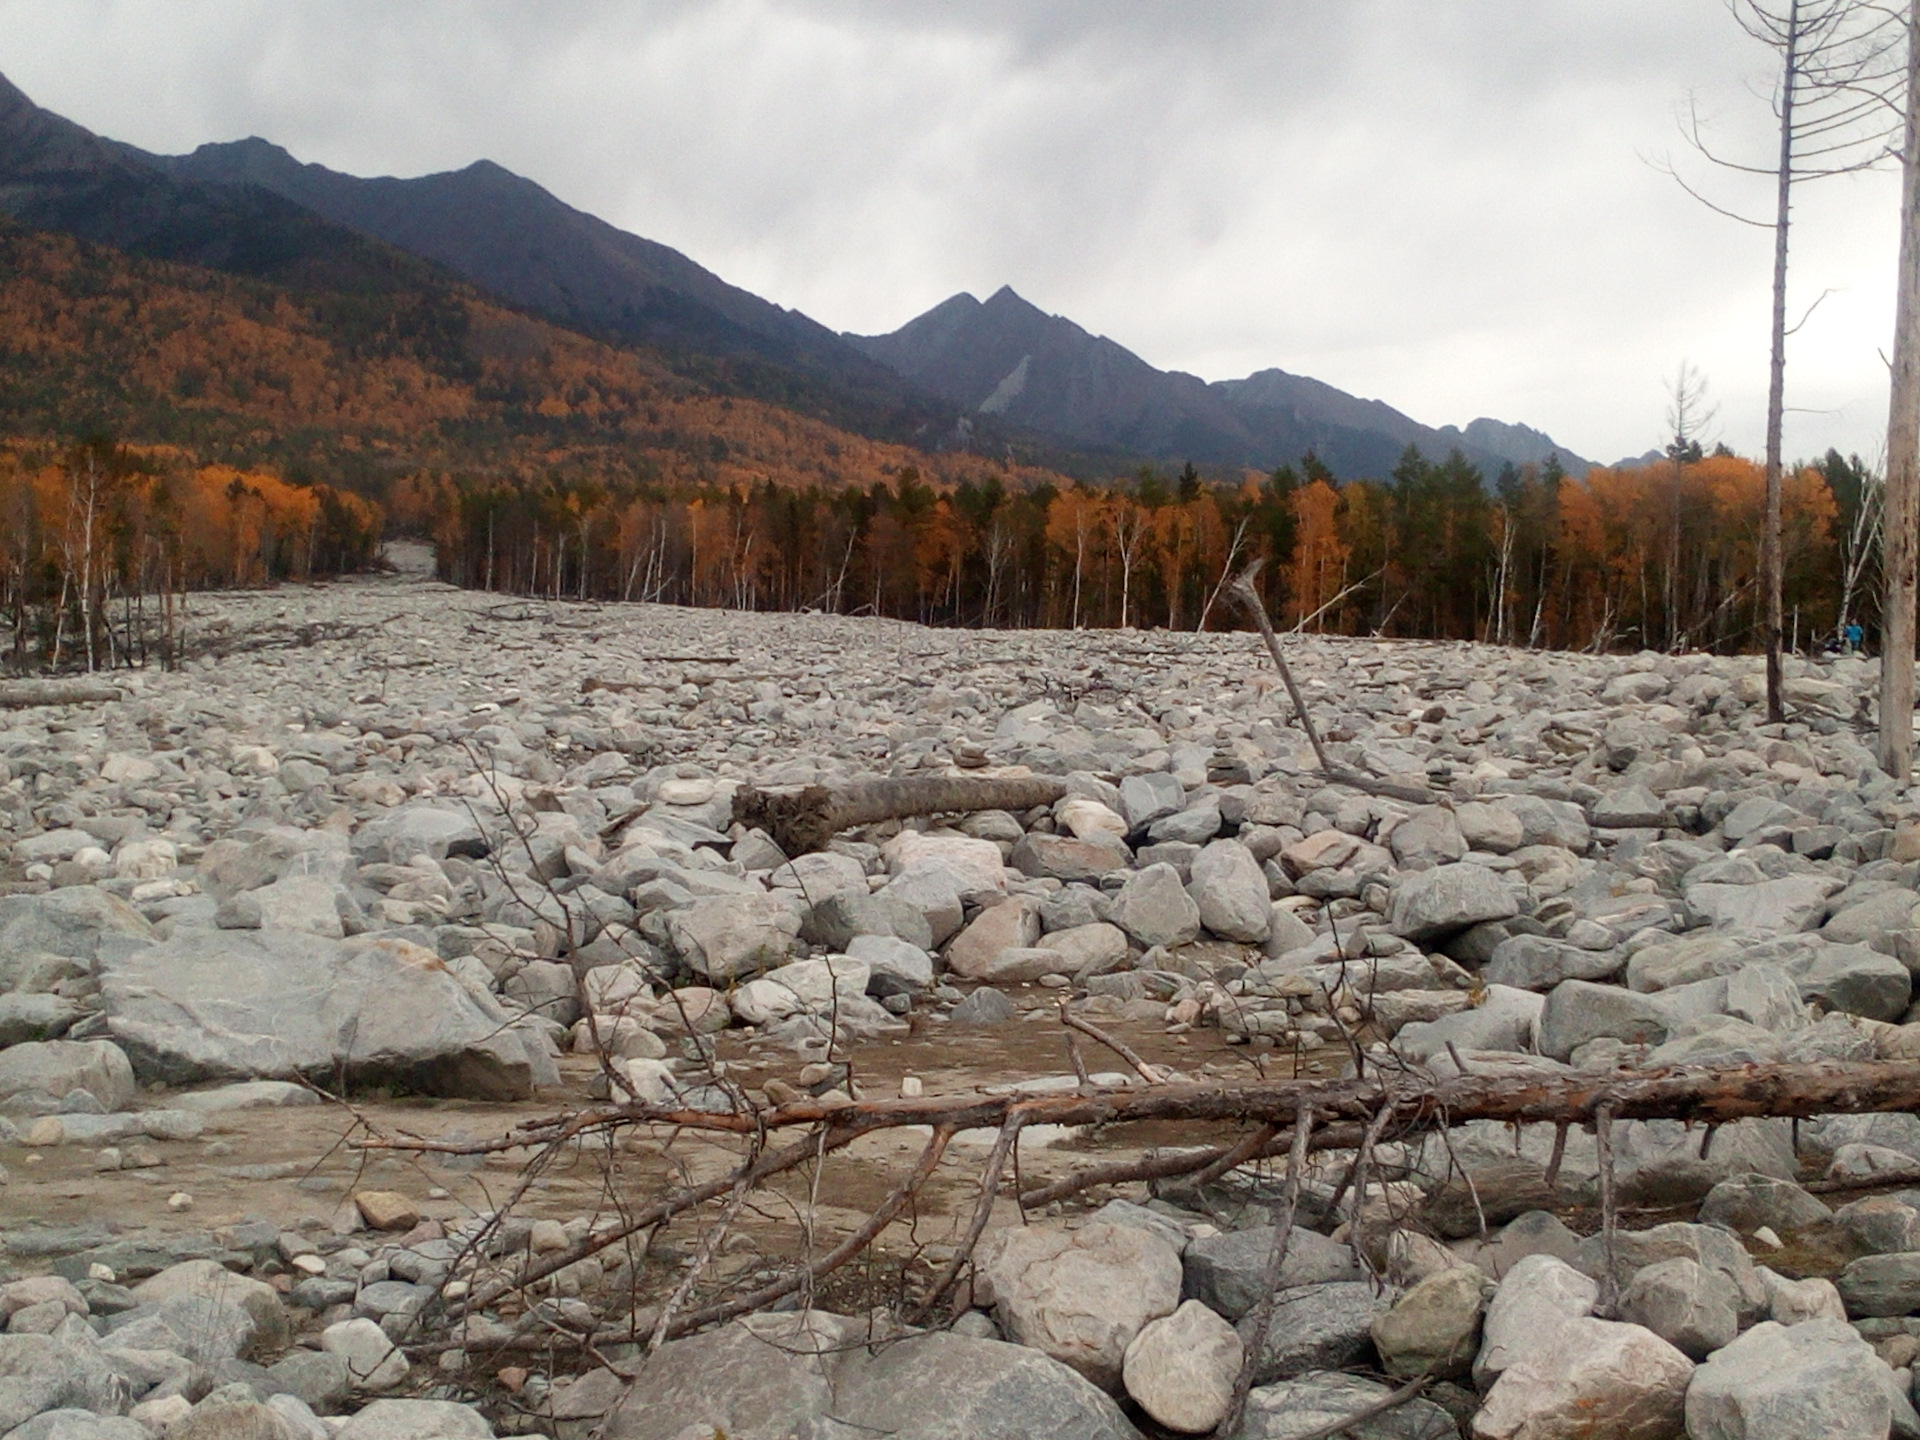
[390,444,1878,651]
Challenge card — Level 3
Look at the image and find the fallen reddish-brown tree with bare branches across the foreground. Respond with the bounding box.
[378,1060,1920,1336]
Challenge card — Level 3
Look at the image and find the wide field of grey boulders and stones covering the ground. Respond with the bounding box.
[0,547,1920,1440]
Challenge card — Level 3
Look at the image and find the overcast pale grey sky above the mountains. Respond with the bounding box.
[0,0,1899,461]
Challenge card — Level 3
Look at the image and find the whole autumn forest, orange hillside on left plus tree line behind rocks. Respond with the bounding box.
[0,227,1878,670]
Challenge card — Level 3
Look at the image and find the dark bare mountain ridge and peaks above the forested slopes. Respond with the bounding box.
[0,77,1586,478]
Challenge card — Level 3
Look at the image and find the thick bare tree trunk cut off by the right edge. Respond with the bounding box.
[1878,0,1920,785]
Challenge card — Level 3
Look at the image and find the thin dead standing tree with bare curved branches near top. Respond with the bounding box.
[1667,0,1905,722]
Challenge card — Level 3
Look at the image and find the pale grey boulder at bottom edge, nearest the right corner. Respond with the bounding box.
[1686,1319,1893,1440]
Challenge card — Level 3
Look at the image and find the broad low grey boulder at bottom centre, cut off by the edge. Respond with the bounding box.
[603,1311,1139,1440]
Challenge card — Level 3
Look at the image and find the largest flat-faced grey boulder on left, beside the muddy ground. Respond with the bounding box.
[102,931,534,1100]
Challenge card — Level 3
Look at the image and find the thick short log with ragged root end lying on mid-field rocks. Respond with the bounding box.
[733,776,1068,856]
